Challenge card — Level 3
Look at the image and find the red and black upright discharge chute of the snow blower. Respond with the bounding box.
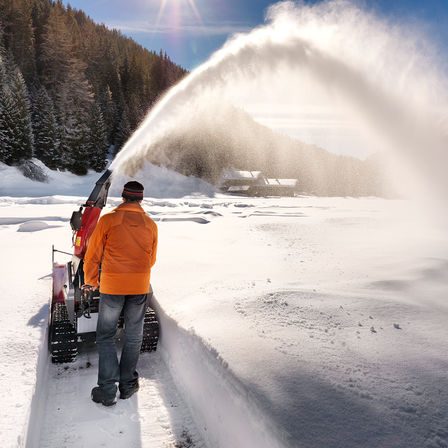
[70,170,112,259]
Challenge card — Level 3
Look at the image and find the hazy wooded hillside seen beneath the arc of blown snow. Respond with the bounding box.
[149,105,390,196]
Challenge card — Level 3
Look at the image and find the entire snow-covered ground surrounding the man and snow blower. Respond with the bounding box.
[0,187,448,448]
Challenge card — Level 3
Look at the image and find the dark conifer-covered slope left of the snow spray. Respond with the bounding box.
[0,0,186,174]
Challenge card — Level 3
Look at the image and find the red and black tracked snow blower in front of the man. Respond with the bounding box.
[48,170,159,363]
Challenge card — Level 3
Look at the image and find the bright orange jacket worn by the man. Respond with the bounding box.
[84,203,157,295]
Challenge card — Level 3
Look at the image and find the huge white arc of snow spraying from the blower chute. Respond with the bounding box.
[112,0,448,200]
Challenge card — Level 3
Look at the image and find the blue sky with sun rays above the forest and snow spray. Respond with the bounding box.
[64,0,448,70]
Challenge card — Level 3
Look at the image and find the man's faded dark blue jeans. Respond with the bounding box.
[96,294,146,397]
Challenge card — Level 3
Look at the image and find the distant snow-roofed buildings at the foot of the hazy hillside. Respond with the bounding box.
[220,170,298,196]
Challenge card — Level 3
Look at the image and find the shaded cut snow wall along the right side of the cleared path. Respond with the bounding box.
[152,299,284,448]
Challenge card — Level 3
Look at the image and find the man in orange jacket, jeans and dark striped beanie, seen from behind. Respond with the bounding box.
[84,181,157,406]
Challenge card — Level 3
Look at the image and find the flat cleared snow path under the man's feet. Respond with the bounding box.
[32,347,205,448]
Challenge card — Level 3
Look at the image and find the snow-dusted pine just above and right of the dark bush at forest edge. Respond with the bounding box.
[32,86,61,169]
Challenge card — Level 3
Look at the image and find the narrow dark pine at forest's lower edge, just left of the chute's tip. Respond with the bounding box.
[87,103,109,172]
